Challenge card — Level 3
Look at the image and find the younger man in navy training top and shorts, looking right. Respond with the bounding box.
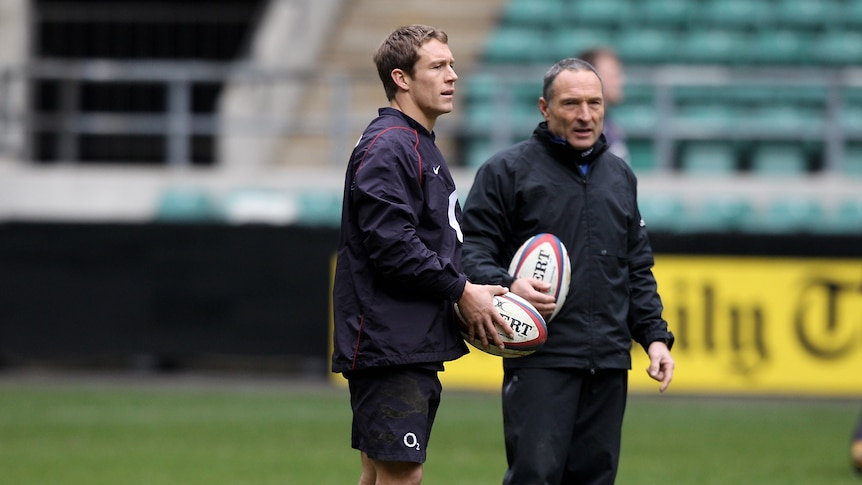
[332,25,513,485]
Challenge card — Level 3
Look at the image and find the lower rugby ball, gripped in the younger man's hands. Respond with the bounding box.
[455,292,548,358]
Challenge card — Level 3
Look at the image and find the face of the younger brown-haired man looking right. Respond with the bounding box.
[406,39,458,121]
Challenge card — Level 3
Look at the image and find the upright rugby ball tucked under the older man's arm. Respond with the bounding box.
[509,233,572,322]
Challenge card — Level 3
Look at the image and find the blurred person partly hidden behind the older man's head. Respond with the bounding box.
[576,47,631,163]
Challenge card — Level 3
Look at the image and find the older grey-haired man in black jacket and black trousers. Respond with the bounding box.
[463,59,675,485]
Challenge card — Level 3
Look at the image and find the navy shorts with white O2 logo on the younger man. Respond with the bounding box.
[344,366,442,463]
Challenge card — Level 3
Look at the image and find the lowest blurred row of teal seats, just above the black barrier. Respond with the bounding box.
[155,187,862,234]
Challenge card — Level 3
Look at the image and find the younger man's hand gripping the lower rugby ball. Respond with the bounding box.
[458,281,515,349]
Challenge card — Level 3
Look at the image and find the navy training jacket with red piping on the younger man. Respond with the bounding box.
[332,108,467,372]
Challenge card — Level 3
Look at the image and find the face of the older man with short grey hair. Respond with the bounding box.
[539,70,605,150]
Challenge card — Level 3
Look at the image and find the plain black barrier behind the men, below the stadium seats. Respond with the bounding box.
[0,223,862,373]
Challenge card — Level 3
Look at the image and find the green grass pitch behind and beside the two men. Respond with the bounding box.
[0,379,862,485]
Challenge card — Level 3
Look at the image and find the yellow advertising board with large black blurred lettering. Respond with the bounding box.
[441,255,862,396]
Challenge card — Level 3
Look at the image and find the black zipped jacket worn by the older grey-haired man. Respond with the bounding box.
[463,122,673,369]
